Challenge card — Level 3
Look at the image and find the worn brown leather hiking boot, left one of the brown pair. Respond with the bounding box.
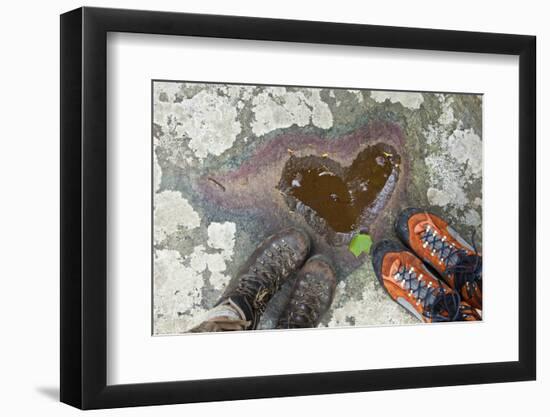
[216,228,310,330]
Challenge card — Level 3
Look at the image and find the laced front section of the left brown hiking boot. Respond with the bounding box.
[236,241,298,314]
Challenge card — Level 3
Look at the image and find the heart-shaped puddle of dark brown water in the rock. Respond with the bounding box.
[282,144,400,233]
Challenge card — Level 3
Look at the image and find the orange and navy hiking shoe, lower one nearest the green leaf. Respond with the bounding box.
[371,240,481,323]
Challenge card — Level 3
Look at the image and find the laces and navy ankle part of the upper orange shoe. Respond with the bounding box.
[420,224,482,297]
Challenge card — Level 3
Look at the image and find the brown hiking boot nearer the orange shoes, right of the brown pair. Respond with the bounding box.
[277,255,336,329]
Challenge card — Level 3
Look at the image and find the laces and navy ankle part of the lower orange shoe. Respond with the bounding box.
[394,265,465,322]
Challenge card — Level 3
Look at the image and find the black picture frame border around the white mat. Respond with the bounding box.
[60,7,536,409]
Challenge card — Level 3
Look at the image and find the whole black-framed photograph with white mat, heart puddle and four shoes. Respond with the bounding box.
[61,7,536,409]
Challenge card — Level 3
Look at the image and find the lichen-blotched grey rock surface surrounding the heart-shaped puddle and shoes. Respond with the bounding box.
[152,82,483,334]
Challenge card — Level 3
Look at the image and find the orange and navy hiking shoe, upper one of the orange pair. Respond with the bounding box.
[395,208,482,309]
